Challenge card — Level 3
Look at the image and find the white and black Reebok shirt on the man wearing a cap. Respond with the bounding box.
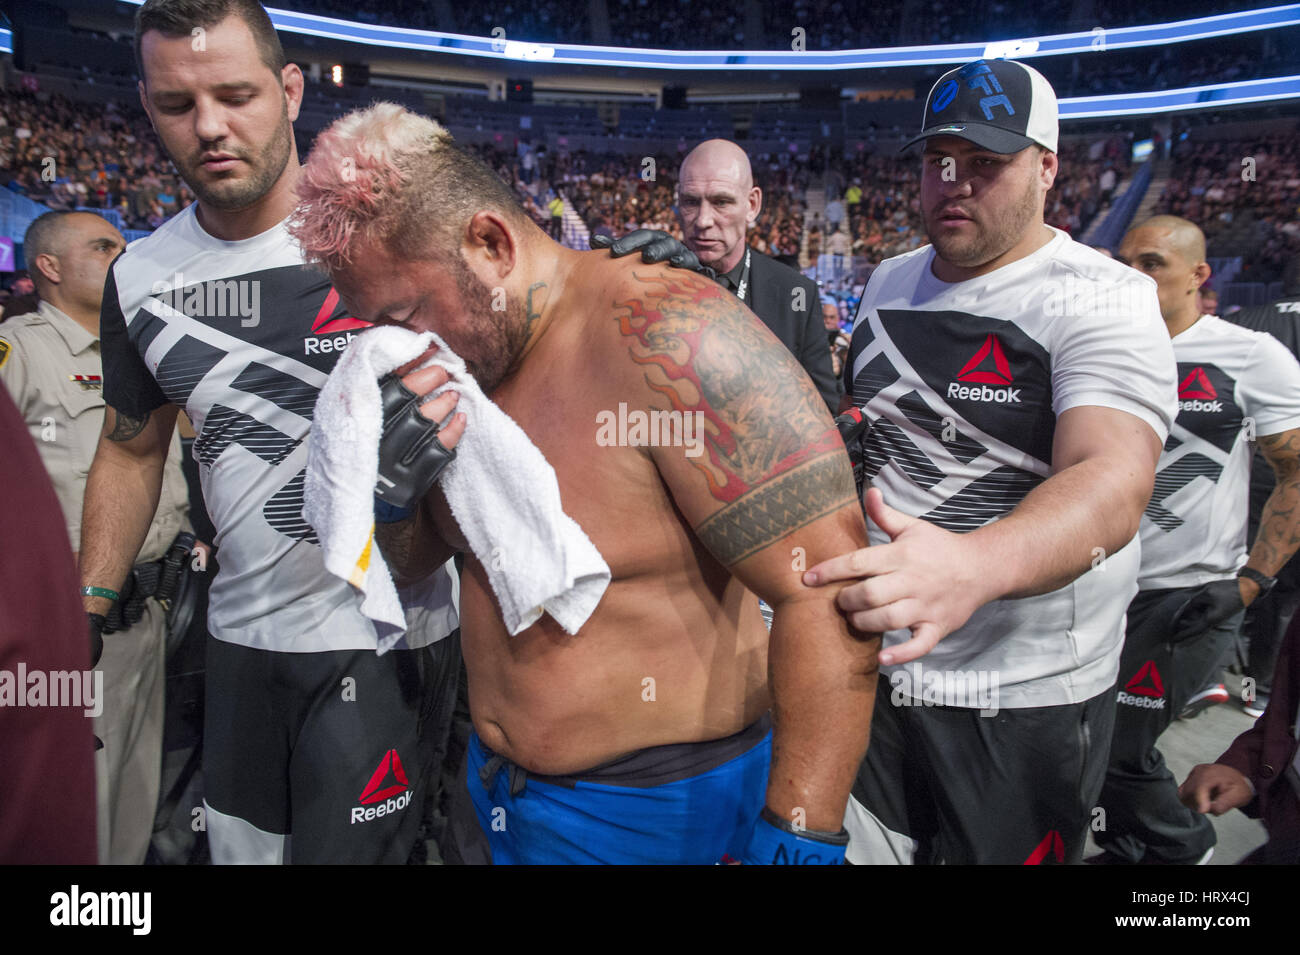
[845,230,1175,708]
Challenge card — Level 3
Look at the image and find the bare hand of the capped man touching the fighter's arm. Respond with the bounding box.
[803,489,996,665]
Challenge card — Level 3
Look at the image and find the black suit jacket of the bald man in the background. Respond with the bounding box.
[745,249,840,416]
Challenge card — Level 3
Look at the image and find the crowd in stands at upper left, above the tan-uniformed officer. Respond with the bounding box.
[0,91,194,229]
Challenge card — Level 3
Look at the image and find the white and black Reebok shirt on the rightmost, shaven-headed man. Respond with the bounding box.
[1138,316,1300,590]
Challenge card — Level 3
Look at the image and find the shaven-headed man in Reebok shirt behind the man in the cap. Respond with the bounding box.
[1089,216,1300,864]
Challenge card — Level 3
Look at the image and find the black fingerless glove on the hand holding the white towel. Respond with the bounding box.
[374,374,456,508]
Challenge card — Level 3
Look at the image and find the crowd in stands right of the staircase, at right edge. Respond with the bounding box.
[1157,133,1300,282]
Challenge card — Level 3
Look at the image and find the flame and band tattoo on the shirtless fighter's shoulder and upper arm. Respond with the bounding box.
[615,273,857,565]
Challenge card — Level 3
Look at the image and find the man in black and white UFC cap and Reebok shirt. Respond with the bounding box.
[805,61,1177,864]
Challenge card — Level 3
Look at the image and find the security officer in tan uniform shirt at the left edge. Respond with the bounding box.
[0,212,192,864]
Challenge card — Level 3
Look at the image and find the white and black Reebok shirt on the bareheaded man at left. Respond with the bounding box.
[100,205,456,652]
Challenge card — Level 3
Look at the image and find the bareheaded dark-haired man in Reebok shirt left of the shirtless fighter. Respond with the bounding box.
[81,0,459,863]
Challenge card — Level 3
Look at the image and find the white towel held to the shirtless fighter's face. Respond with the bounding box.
[304,326,610,648]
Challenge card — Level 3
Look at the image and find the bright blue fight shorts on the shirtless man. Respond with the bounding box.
[467,715,772,865]
